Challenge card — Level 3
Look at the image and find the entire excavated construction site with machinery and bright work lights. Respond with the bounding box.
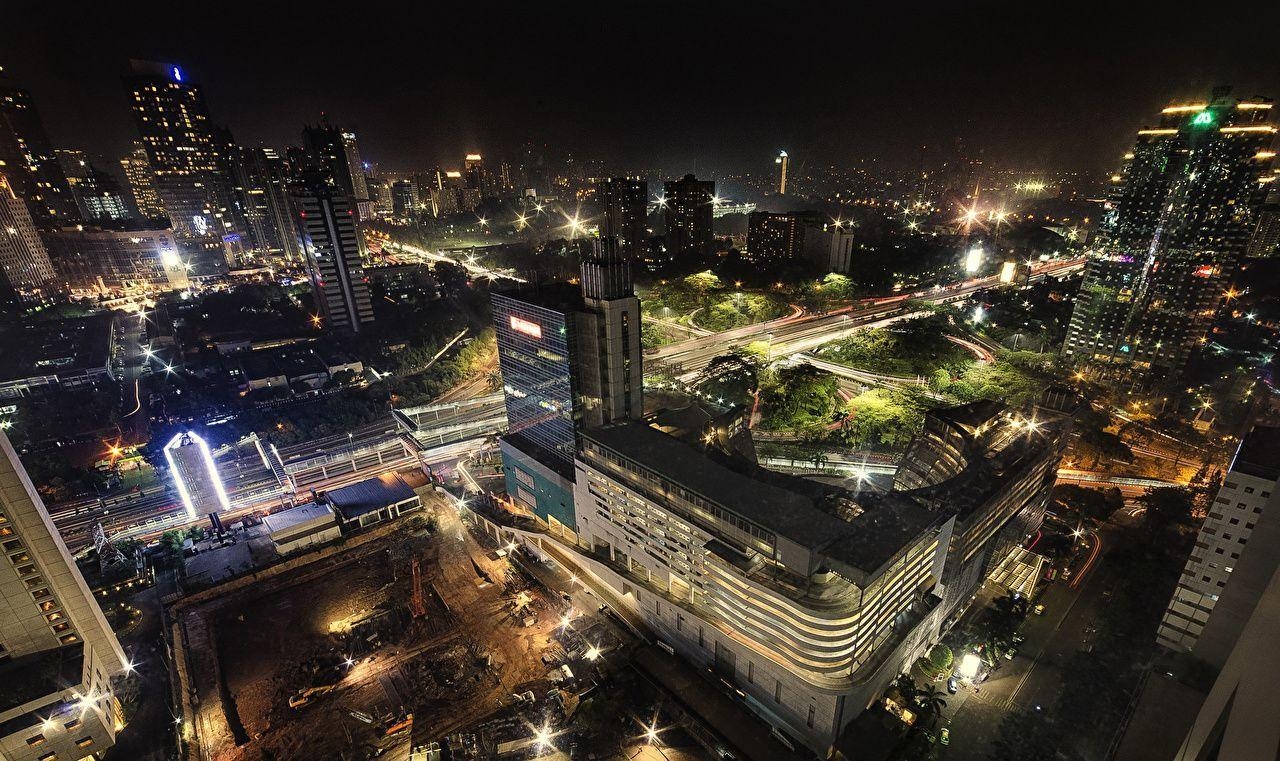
[169,492,694,761]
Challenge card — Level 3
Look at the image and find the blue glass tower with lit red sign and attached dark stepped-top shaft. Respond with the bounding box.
[492,239,644,527]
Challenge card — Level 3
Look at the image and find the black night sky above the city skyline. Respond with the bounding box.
[0,0,1280,173]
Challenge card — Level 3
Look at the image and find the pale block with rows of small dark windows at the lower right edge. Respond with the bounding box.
[1156,426,1280,668]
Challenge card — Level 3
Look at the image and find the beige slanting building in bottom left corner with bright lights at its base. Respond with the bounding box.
[0,432,132,761]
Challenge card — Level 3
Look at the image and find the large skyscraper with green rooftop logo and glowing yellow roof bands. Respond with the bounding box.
[1062,88,1276,373]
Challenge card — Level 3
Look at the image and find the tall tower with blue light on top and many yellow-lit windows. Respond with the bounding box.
[125,60,237,238]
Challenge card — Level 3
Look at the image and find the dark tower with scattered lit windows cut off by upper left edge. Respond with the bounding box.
[0,67,79,228]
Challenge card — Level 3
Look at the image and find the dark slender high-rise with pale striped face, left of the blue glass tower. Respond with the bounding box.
[293,178,374,333]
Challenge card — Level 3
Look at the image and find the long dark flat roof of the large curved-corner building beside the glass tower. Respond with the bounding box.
[582,422,942,573]
